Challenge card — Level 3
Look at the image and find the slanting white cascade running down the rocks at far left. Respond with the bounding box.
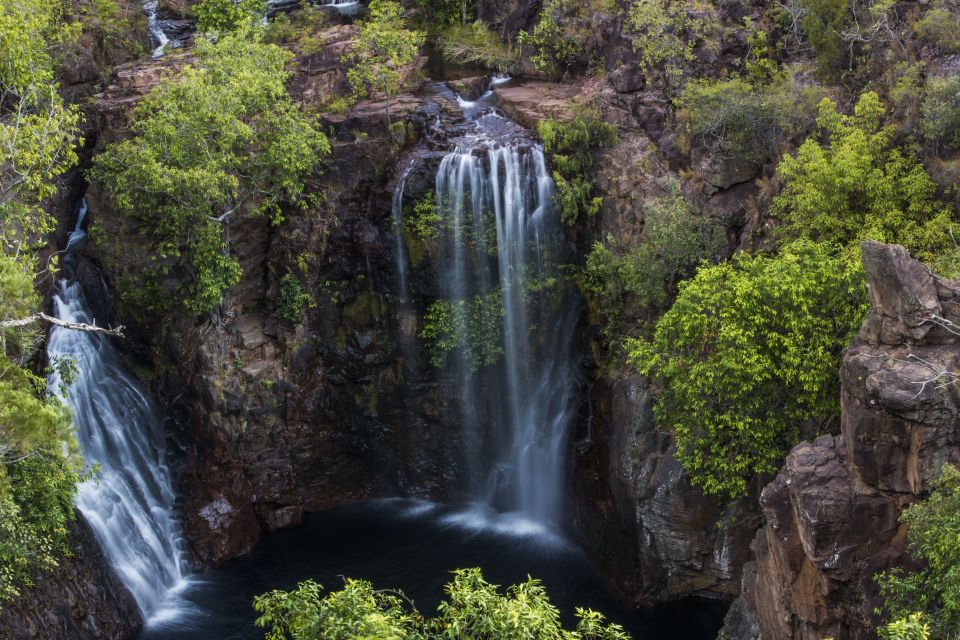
[47,202,187,619]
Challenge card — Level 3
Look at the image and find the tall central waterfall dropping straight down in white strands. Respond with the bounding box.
[435,104,576,523]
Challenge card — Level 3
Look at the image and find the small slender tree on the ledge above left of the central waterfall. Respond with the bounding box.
[343,0,426,122]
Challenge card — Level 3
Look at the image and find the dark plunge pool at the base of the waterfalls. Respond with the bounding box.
[140,499,724,640]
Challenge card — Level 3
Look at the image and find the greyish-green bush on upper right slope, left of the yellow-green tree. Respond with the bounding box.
[675,71,824,164]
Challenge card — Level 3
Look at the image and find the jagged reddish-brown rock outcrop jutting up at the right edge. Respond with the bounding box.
[724,242,960,640]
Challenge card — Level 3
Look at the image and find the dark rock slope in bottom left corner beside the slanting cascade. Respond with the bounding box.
[0,513,143,640]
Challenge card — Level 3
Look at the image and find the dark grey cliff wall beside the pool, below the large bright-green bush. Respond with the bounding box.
[575,374,756,605]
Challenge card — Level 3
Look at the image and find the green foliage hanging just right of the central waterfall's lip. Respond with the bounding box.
[537,108,617,225]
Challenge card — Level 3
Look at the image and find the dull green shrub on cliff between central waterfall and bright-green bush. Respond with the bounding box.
[580,185,724,329]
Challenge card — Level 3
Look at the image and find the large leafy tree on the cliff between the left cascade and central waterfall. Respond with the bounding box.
[92,30,330,314]
